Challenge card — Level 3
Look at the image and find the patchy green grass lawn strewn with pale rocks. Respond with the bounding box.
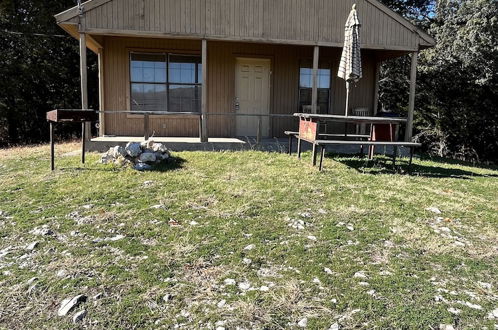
[0,144,498,329]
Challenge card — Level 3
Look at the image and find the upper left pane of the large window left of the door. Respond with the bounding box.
[131,54,166,83]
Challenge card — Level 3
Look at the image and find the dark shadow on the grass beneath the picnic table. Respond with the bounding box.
[327,154,498,180]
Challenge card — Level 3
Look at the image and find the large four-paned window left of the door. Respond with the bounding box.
[130,53,202,112]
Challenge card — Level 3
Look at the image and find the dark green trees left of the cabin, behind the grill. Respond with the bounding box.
[0,0,97,146]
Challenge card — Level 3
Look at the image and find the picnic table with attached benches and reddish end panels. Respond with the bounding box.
[285,113,421,171]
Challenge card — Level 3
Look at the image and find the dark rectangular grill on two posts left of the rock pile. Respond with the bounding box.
[47,109,97,171]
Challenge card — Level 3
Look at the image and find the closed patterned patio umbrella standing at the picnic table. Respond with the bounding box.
[338,4,362,116]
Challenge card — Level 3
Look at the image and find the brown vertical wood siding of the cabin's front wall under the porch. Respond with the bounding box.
[104,37,377,137]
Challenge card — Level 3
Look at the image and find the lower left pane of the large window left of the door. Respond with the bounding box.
[131,83,167,111]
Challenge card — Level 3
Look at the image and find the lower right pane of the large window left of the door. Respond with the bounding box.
[169,85,201,112]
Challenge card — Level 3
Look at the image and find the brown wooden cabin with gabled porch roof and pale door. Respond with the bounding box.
[55,0,435,141]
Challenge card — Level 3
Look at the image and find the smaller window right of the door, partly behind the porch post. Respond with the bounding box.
[299,61,331,113]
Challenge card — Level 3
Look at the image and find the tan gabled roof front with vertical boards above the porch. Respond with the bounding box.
[55,0,435,51]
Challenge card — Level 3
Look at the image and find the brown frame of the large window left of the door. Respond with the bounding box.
[127,50,204,114]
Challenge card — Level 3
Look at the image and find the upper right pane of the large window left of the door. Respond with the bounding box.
[169,55,202,84]
